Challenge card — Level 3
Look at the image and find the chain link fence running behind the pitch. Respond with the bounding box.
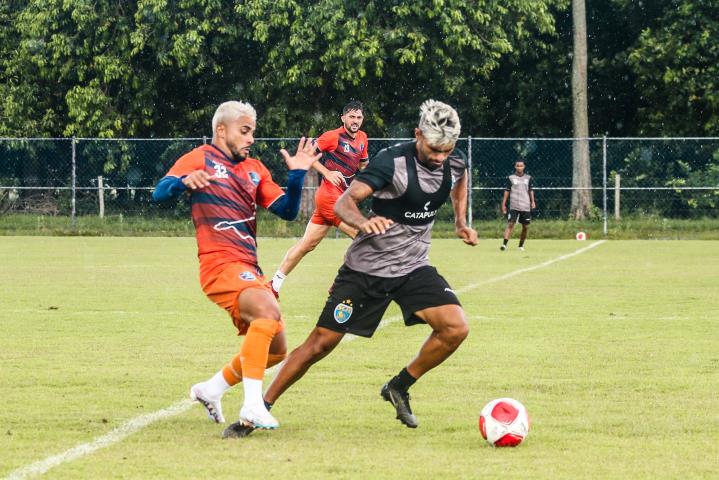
[0,137,719,233]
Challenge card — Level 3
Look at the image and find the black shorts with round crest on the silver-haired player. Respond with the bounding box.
[317,265,461,337]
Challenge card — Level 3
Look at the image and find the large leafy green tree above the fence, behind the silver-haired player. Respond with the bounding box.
[237,0,561,136]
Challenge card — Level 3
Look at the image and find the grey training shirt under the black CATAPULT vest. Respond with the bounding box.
[345,142,467,277]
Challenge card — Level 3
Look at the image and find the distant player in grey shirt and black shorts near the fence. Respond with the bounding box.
[499,160,537,250]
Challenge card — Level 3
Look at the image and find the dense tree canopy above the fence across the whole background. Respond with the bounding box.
[0,0,719,137]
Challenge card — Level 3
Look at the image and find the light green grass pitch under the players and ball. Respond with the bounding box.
[0,237,719,479]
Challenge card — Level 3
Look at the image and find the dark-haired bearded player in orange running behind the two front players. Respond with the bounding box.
[272,100,369,296]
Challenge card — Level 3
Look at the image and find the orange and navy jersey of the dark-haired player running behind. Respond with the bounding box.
[317,127,369,192]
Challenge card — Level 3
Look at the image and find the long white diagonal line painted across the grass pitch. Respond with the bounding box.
[7,240,606,480]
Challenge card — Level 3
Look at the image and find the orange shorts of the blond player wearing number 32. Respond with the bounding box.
[201,263,285,335]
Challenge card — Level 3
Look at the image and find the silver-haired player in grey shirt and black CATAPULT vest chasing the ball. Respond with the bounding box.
[264,100,477,428]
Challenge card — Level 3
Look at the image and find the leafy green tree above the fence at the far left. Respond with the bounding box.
[3,0,152,137]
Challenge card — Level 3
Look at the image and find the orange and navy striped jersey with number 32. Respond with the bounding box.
[167,145,284,278]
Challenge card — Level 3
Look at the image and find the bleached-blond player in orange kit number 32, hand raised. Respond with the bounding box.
[153,101,320,429]
